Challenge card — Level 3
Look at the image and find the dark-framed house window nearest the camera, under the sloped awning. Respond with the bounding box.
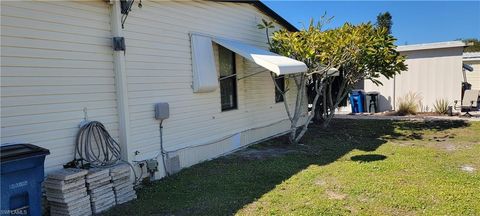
[218,46,237,111]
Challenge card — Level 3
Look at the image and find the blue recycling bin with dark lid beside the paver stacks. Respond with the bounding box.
[0,144,50,215]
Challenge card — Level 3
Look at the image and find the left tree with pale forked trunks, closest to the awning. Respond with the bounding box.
[258,20,349,143]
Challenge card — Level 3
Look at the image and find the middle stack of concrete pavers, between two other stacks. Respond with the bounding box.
[86,168,115,214]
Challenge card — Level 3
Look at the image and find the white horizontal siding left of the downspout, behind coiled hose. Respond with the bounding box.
[1,1,118,172]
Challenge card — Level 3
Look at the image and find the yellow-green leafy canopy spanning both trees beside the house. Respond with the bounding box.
[266,20,407,85]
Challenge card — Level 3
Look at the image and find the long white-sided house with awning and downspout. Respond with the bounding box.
[1,0,305,177]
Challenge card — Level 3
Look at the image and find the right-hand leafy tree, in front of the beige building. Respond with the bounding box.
[316,23,407,127]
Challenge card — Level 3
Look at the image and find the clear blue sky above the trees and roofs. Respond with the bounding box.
[262,0,480,45]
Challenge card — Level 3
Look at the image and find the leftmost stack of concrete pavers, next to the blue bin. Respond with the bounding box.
[43,168,92,216]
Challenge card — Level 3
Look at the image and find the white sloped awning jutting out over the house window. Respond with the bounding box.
[213,38,307,75]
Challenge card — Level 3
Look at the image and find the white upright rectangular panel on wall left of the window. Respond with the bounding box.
[191,35,218,93]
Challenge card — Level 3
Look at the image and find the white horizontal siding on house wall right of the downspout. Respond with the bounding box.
[125,1,293,170]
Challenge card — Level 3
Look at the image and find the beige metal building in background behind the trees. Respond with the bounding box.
[364,41,465,111]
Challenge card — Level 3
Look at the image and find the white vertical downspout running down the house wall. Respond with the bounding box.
[110,0,133,162]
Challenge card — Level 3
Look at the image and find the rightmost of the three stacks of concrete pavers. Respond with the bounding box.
[110,163,137,205]
